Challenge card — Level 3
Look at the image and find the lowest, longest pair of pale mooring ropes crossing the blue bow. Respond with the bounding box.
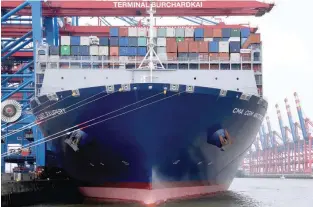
[1,92,180,157]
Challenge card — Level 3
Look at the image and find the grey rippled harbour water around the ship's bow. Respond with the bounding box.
[38,178,313,207]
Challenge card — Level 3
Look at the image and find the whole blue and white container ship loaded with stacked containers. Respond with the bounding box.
[31,4,267,204]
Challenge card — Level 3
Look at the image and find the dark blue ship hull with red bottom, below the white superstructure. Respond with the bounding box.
[31,83,267,203]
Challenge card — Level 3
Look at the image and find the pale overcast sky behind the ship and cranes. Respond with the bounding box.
[80,0,313,134]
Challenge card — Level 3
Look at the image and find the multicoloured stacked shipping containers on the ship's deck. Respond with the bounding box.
[54,27,260,62]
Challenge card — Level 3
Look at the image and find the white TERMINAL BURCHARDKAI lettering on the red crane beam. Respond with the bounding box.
[113,1,203,8]
